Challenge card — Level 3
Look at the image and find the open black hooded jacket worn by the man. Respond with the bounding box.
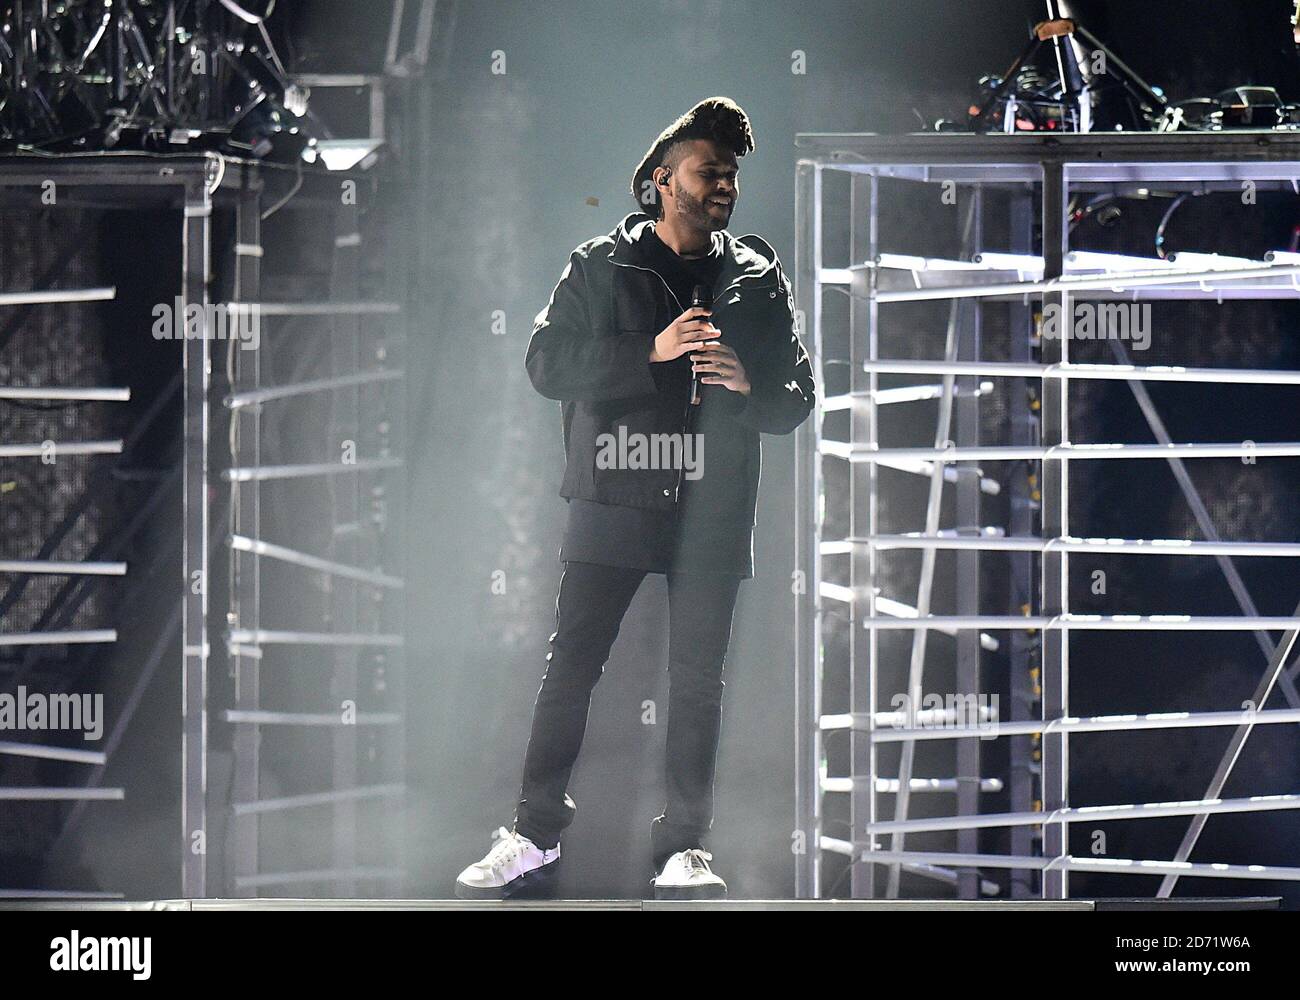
[525,212,816,524]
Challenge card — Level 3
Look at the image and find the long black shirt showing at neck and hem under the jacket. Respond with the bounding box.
[560,222,754,579]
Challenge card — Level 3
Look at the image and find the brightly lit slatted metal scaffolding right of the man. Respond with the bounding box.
[796,131,1300,899]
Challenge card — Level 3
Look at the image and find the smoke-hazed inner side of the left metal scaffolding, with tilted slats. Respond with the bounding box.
[221,163,406,897]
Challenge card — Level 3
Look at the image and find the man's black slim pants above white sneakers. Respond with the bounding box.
[515,562,740,870]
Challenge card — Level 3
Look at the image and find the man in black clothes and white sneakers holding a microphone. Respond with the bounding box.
[456,98,815,899]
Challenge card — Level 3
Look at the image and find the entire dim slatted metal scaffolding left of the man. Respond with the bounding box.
[0,153,407,899]
